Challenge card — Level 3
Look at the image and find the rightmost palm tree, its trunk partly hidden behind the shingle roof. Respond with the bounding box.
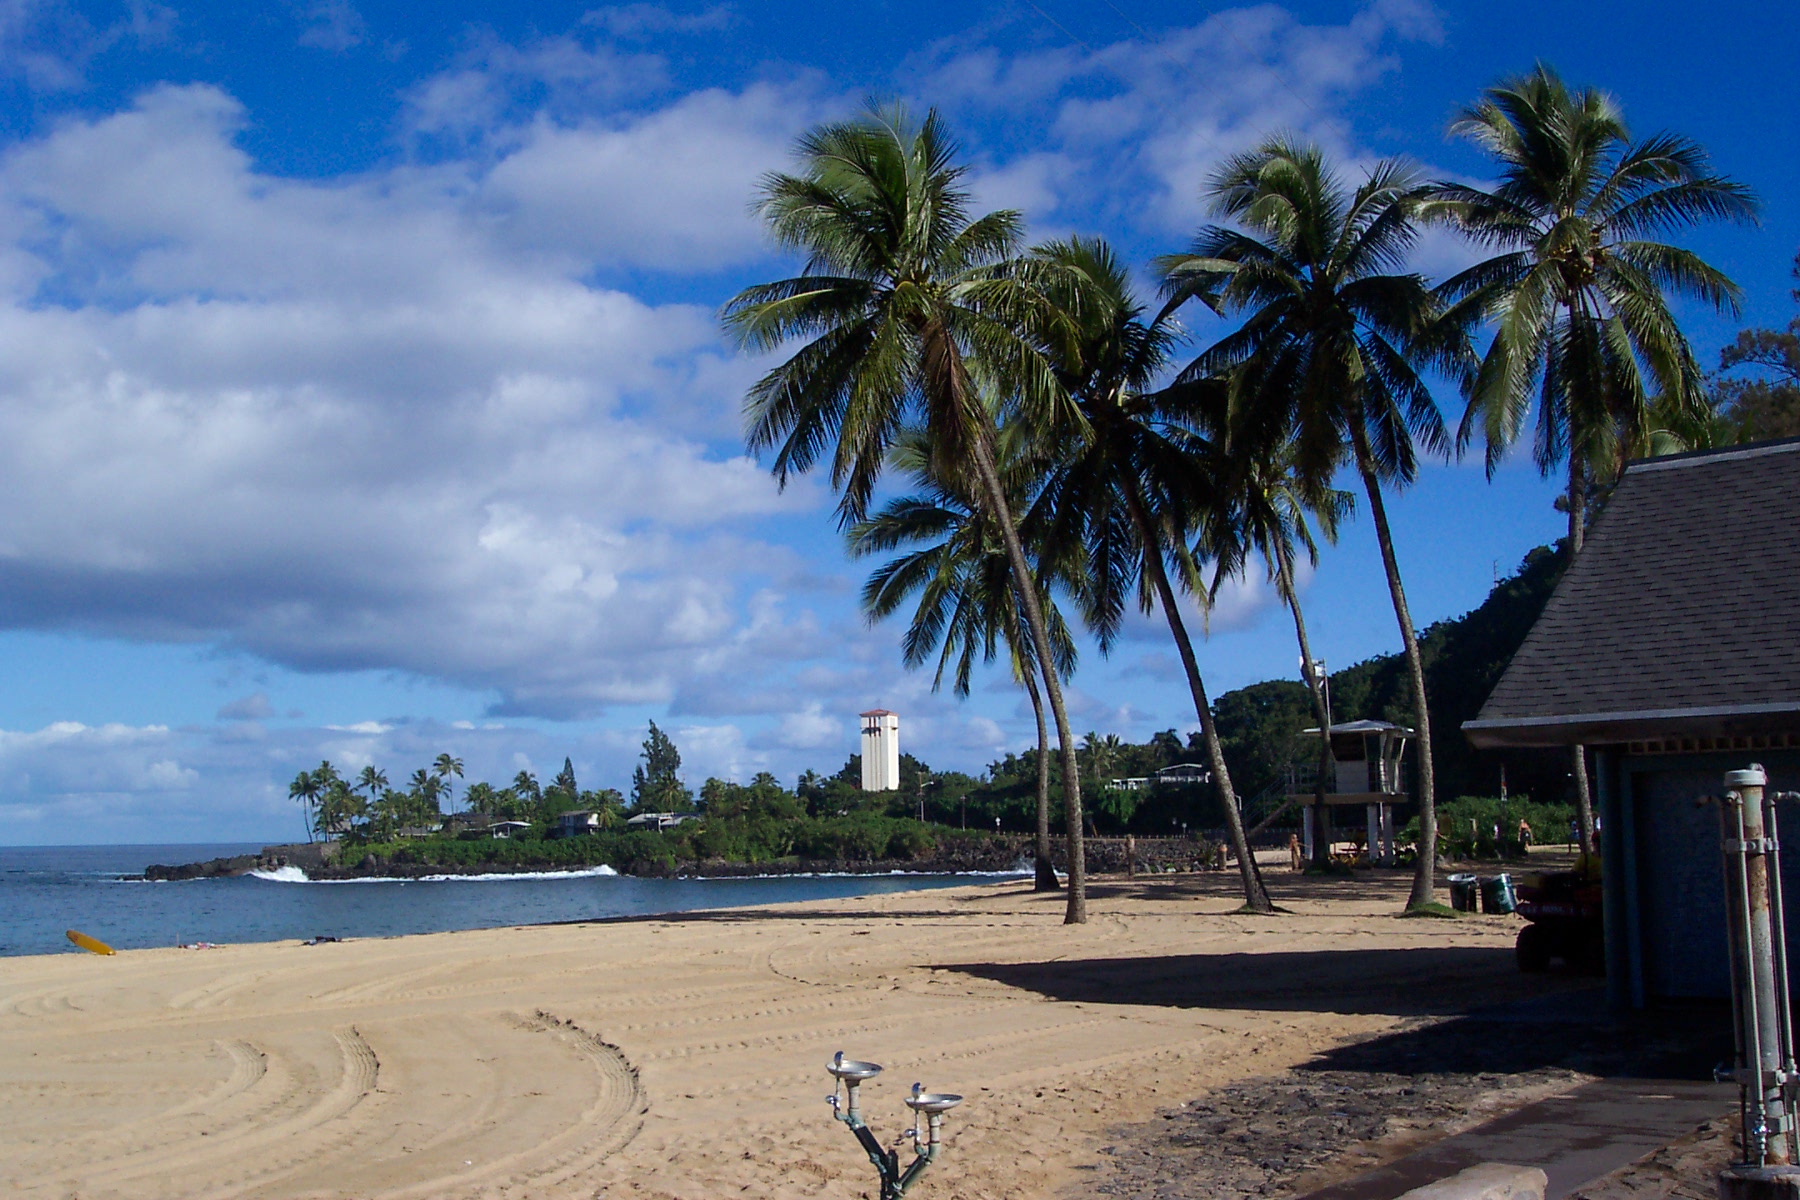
[1429,63,1757,853]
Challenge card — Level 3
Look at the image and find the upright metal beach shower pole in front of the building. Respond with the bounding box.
[1719,763,1800,1166]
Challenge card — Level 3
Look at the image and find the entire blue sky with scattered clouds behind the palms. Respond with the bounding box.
[0,0,1800,844]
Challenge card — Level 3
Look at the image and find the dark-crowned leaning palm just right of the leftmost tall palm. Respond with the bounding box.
[1033,239,1274,912]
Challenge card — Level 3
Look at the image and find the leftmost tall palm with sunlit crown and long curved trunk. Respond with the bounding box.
[724,110,1087,923]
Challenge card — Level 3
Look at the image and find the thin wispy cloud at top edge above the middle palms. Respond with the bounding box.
[905,0,1442,234]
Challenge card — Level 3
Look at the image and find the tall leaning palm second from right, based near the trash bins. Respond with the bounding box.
[1159,139,1467,909]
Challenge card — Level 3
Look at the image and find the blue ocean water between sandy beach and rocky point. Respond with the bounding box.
[0,846,1015,955]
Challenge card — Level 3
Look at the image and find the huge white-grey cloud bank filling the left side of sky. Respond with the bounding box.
[0,88,842,714]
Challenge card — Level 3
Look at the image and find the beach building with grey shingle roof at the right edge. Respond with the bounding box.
[1463,439,1800,1007]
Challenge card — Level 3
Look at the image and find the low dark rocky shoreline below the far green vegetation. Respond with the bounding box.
[126,835,1215,882]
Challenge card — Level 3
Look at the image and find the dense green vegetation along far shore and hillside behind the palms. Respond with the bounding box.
[295,547,1570,873]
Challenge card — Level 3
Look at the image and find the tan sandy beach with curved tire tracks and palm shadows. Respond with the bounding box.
[0,876,1570,1200]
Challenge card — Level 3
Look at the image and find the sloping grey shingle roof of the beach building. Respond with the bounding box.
[1463,439,1800,747]
